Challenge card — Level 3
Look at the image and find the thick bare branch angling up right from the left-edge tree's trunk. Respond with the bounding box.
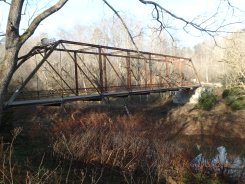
[20,0,68,43]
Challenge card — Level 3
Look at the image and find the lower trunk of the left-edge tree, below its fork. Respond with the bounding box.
[0,46,20,126]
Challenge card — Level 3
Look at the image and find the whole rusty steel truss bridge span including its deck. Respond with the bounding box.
[6,40,200,108]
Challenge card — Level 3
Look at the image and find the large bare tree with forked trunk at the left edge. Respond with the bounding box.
[0,0,68,126]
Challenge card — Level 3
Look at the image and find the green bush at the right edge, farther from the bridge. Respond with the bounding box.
[222,88,245,110]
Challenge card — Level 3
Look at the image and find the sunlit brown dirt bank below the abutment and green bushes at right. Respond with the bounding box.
[166,102,245,139]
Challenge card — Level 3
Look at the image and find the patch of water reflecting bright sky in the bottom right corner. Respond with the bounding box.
[190,146,245,182]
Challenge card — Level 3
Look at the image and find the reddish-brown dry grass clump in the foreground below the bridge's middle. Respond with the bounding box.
[52,112,188,182]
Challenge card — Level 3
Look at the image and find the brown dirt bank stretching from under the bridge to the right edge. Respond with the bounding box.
[8,97,245,140]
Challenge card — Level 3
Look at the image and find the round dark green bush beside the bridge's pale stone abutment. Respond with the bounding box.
[197,90,217,110]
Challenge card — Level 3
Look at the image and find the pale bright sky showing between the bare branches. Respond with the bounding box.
[0,0,245,46]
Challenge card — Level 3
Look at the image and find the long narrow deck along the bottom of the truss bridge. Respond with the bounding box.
[6,85,200,108]
